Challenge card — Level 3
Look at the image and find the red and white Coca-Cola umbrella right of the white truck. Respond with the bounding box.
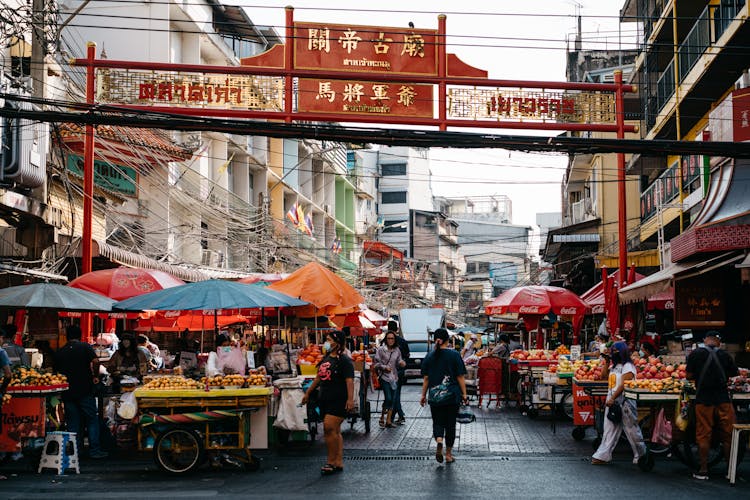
[485,285,586,343]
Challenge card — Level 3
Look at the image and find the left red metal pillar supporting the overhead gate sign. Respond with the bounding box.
[81,42,96,341]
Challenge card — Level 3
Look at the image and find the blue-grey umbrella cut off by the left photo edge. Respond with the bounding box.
[0,283,115,312]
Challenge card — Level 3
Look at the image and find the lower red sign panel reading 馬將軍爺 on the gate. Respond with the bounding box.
[298,78,433,118]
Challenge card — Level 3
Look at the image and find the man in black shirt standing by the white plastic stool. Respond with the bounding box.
[55,325,108,458]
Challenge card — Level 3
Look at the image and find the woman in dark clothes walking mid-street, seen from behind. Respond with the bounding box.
[420,328,467,463]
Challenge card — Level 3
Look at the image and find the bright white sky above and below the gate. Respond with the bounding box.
[232,0,632,226]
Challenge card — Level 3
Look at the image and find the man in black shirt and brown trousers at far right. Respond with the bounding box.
[687,330,737,481]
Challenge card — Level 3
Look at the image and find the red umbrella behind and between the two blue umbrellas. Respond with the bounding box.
[68,267,185,300]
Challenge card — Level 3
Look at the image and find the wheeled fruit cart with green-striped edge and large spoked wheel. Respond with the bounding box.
[134,383,273,474]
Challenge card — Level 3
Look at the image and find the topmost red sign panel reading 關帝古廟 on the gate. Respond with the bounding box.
[294,23,437,75]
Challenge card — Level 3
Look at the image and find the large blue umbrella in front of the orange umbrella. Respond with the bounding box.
[114,280,307,311]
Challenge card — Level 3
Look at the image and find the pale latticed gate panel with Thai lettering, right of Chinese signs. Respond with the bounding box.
[447,87,616,123]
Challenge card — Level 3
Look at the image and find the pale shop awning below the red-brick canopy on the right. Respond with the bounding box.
[619,252,743,304]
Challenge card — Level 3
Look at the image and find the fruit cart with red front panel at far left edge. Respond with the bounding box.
[0,367,68,453]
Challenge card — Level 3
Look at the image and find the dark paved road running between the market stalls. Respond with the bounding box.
[0,386,750,499]
